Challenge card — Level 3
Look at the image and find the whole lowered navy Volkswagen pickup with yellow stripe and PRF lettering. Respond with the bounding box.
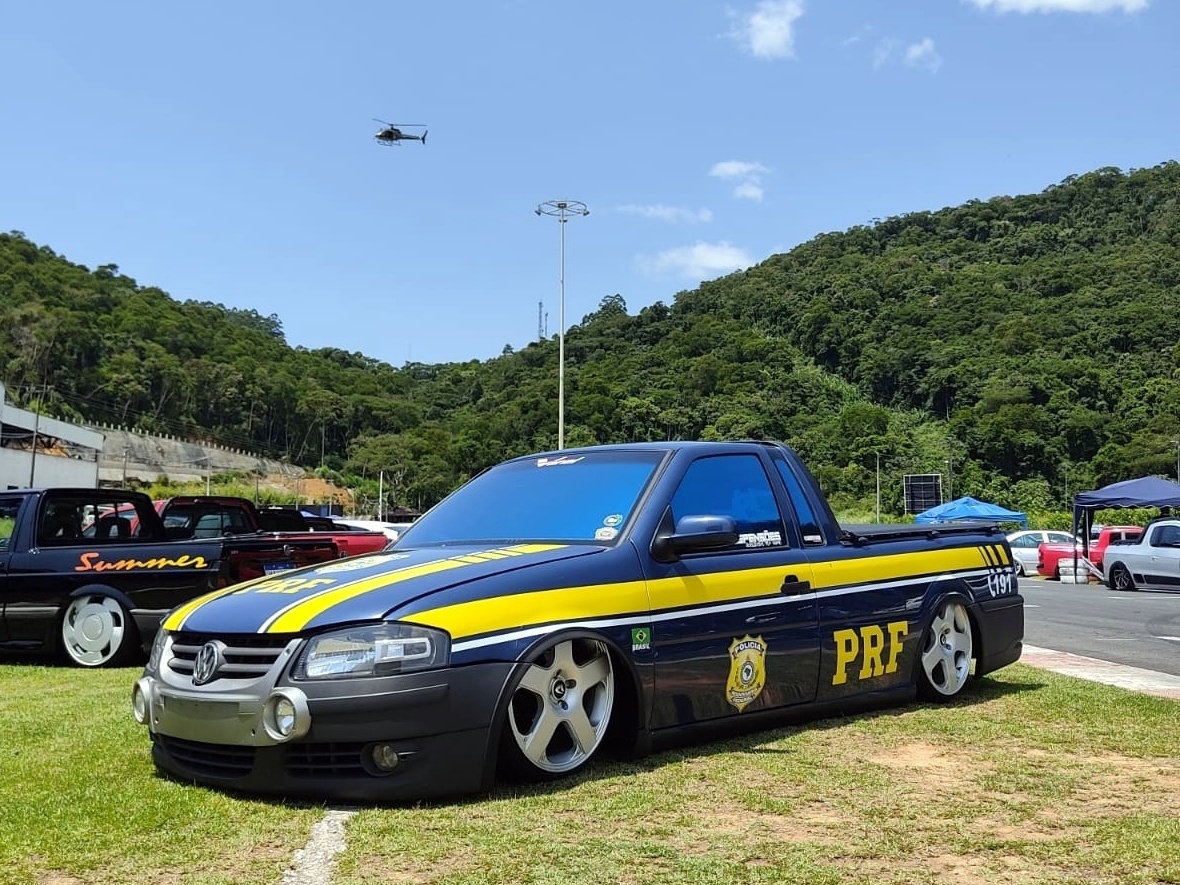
[133,441,1024,800]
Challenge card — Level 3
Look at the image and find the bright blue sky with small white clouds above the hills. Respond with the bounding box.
[0,0,1180,367]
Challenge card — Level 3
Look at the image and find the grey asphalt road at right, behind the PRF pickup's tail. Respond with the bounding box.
[1021,578,1180,676]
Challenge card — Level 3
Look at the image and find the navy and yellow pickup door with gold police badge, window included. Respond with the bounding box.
[645,453,819,728]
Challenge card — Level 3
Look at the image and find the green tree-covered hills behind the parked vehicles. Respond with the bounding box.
[0,163,1180,512]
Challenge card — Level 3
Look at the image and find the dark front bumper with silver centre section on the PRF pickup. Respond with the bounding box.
[136,663,513,802]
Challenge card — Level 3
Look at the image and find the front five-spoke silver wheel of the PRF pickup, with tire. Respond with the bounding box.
[500,637,616,781]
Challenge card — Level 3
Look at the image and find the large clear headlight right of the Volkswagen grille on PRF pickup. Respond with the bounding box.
[293,624,451,680]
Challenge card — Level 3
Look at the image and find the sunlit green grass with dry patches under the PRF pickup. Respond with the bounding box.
[0,664,1180,885]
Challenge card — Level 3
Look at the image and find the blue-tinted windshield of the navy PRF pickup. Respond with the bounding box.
[399,451,663,545]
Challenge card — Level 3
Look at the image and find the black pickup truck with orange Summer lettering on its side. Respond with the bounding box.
[0,489,339,667]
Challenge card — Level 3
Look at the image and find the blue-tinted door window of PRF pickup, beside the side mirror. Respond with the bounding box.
[671,454,787,548]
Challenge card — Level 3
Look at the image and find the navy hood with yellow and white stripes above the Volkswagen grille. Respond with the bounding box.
[164,544,602,634]
